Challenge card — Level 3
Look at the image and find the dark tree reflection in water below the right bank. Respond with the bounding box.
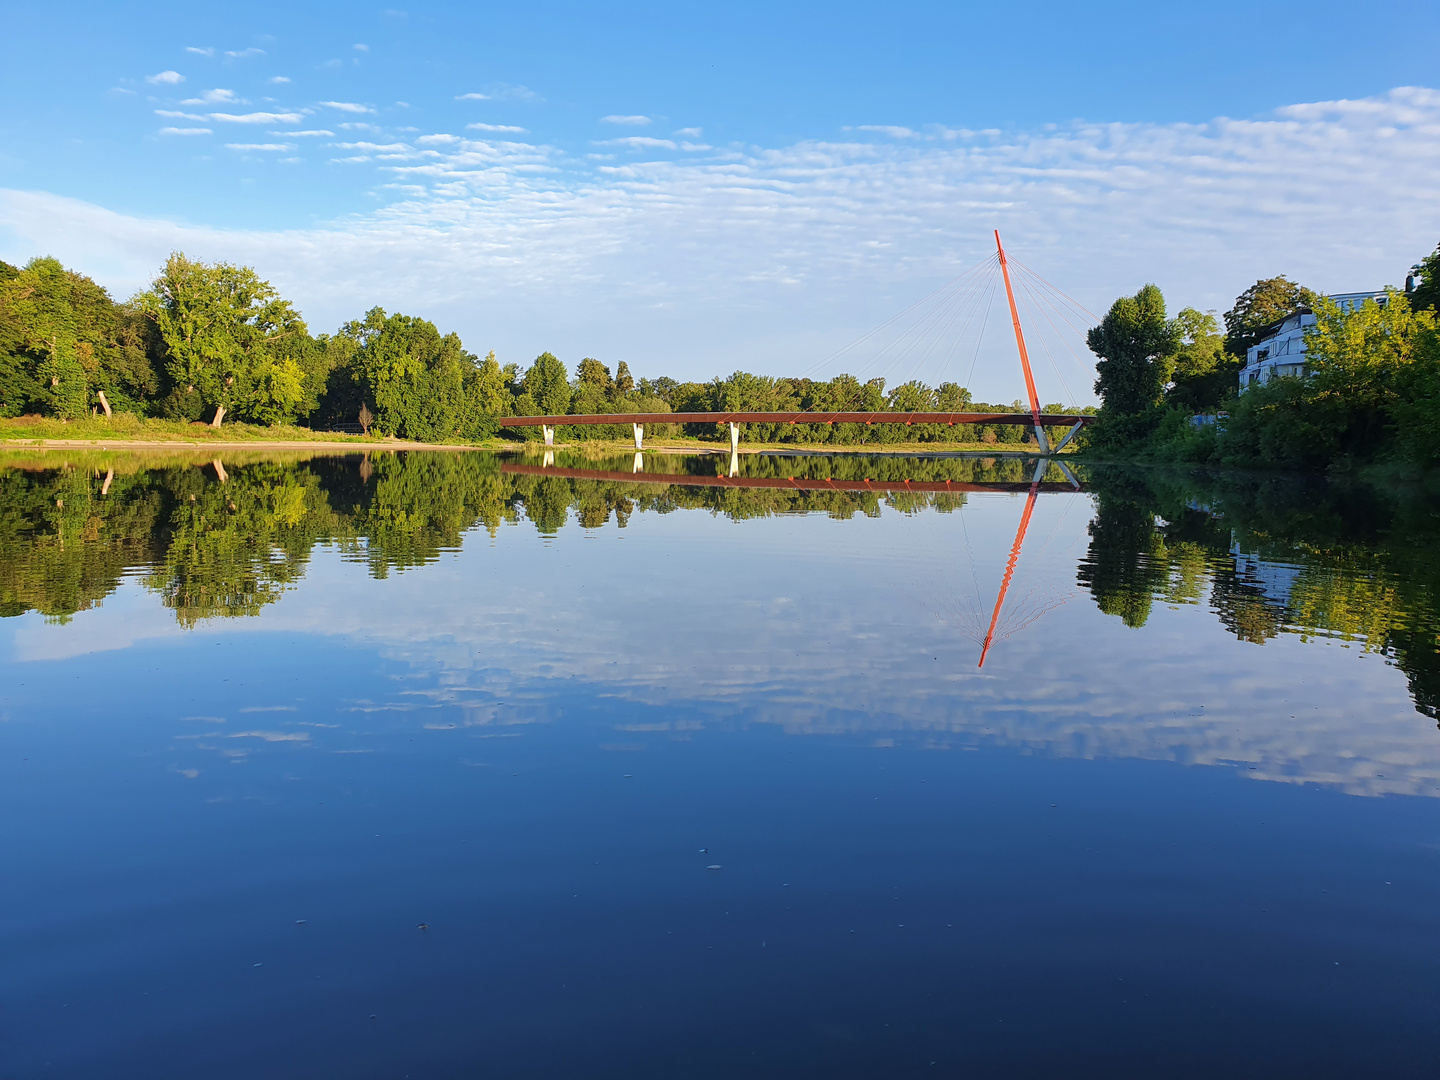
[1079,467,1440,720]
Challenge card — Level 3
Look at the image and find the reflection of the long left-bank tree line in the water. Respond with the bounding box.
[0,454,1027,625]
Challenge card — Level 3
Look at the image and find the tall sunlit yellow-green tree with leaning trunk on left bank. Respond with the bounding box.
[140,252,310,426]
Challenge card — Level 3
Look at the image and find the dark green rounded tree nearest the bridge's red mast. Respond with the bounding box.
[1086,285,1179,416]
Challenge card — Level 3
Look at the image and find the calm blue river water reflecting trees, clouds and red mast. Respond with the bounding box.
[0,452,1440,1080]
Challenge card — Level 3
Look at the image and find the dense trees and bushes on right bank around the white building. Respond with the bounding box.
[1086,246,1440,468]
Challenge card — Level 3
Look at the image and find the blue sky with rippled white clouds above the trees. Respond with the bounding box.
[0,0,1440,403]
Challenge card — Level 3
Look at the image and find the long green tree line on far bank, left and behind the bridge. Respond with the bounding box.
[0,252,1070,445]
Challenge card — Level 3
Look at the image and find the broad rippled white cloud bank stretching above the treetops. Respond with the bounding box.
[11,89,1440,402]
